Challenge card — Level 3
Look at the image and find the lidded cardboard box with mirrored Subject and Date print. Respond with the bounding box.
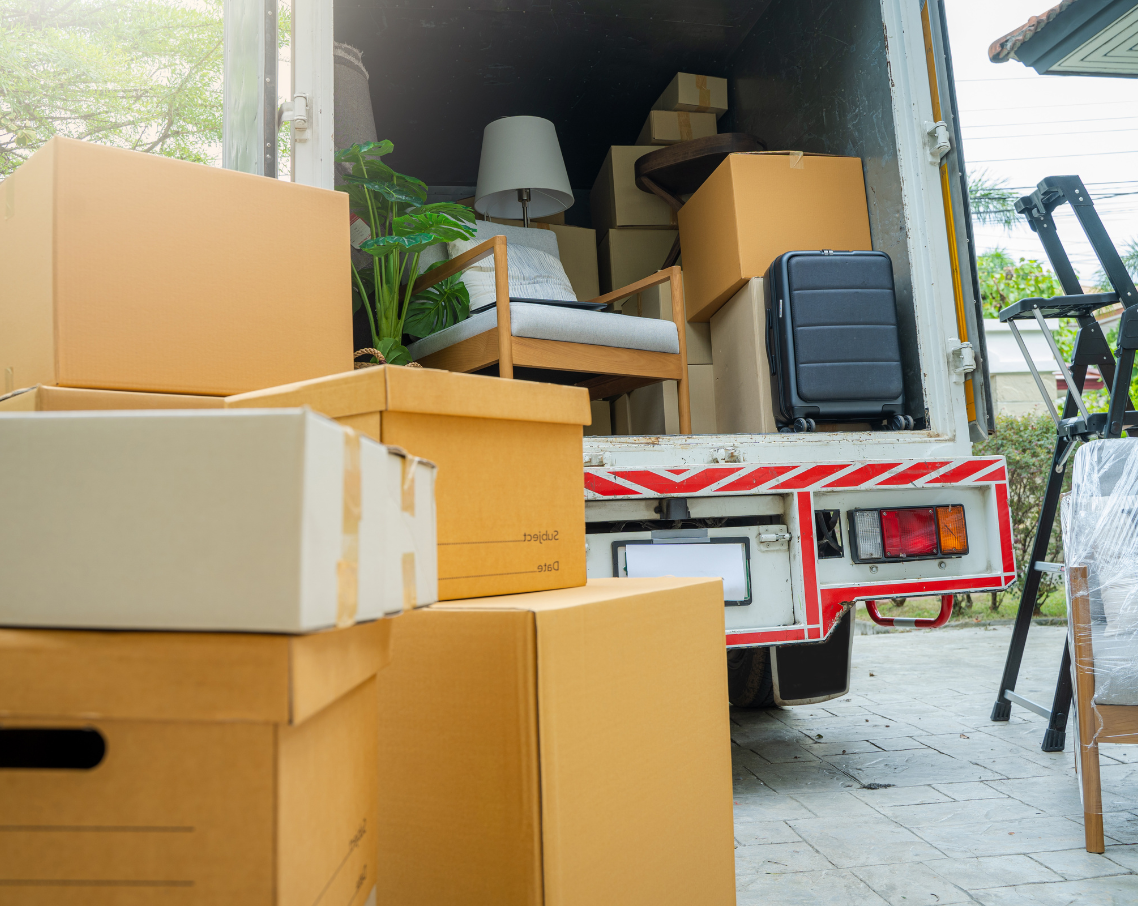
[225,365,589,601]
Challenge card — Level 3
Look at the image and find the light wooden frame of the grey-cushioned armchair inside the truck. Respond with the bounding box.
[414,236,692,434]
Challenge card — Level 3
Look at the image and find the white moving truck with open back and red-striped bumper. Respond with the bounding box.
[235,0,1015,707]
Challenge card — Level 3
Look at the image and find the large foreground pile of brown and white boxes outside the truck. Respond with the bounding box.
[0,139,734,906]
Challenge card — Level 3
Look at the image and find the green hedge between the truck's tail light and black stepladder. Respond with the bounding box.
[972,414,1071,611]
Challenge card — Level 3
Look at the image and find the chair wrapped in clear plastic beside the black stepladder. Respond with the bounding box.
[1063,438,1138,853]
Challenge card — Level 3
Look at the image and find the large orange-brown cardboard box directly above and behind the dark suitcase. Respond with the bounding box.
[679,151,873,321]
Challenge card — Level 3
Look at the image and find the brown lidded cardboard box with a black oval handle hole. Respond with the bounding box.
[0,620,394,906]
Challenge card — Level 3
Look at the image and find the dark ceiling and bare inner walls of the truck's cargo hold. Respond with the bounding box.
[335,0,925,425]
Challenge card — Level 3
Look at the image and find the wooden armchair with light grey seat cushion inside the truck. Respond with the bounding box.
[412,236,692,434]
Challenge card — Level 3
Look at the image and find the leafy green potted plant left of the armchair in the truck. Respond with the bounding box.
[336,139,475,365]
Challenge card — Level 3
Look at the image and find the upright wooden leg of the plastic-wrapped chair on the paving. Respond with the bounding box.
[1067,566,1106,853]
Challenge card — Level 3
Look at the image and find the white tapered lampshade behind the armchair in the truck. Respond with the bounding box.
[475,116,574,220]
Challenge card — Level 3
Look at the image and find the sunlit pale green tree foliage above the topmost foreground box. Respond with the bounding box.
[0,0,223,176]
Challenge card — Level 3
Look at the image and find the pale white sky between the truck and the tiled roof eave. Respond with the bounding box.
[945,0,1138,282]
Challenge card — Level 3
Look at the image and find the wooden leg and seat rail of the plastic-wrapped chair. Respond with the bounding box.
[1067,566,1138,853]
